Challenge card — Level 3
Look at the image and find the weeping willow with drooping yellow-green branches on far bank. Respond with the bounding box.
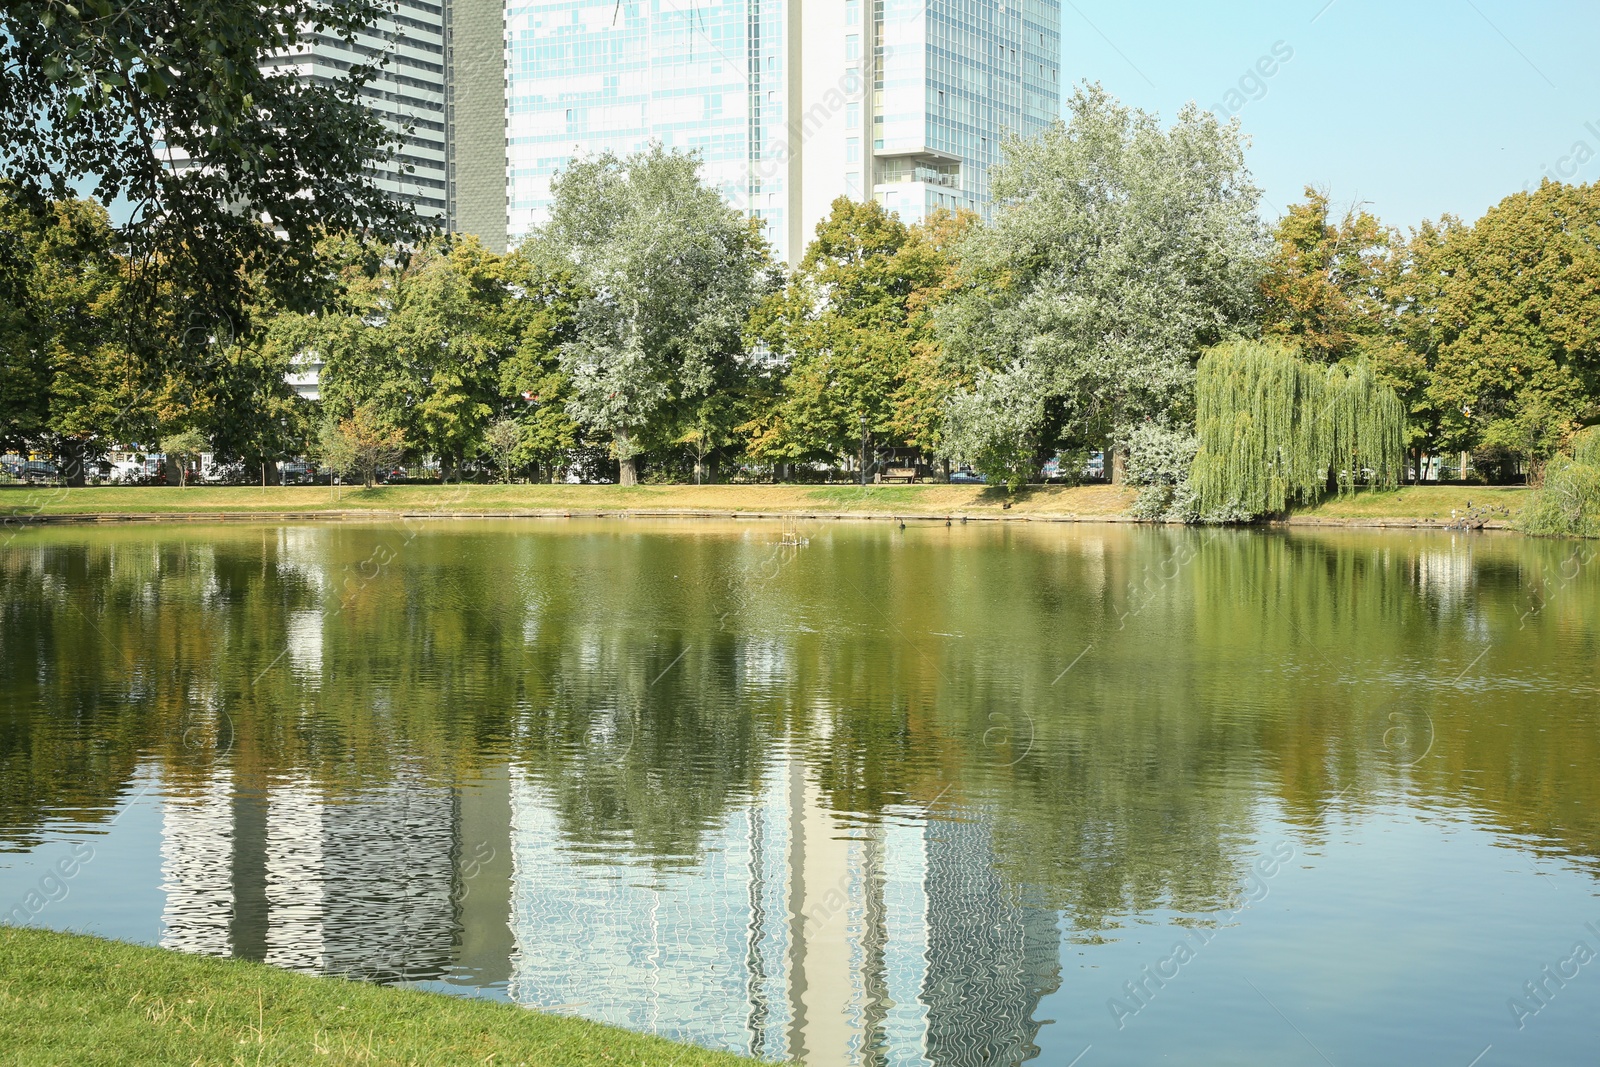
[1190,341,1405,515]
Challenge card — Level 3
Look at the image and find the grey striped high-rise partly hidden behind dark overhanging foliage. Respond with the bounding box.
[264,0,506,251]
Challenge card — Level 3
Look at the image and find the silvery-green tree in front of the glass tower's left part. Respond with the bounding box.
[539,144,766,485]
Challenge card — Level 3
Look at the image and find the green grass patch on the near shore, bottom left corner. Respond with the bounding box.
[0,926,755,1067]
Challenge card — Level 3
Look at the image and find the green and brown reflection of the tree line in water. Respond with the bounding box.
[0,526,1600,929]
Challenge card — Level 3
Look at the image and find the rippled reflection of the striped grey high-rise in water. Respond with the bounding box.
[162,773,464,979]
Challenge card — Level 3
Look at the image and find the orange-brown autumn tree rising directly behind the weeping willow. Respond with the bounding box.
[1261,186,1392,363]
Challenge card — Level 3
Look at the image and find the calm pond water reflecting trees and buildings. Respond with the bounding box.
[0,520,1600,1067]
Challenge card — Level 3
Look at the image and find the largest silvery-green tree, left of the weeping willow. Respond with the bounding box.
[938,85,1264,482]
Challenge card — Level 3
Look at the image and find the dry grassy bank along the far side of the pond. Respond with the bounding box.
[0,485,1528,525]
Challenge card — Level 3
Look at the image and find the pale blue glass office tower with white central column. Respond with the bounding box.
[506,0,1061,262]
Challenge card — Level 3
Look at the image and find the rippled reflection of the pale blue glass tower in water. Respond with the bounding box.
[510,751,1059,1065]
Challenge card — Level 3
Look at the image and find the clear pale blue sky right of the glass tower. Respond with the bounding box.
[1061,0,1600,227]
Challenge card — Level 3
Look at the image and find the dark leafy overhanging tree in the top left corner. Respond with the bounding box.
[0,0,411,363]
